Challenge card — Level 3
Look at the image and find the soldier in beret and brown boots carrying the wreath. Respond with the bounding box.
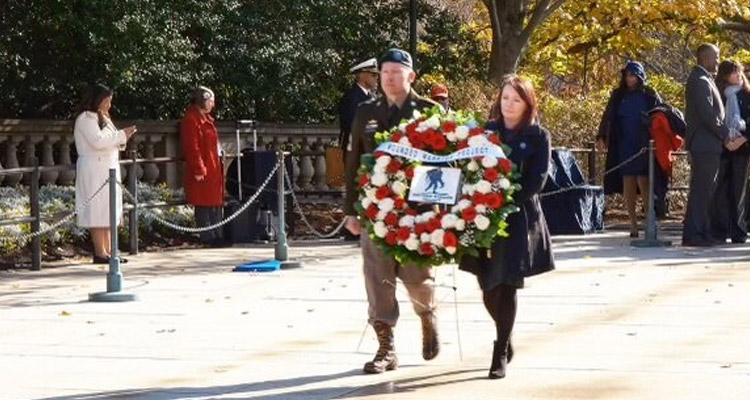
[344,49,440,373]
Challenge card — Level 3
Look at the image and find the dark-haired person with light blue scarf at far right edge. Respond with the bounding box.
[711,60,750,243]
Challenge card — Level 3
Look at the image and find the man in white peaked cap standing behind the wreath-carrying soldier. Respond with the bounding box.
[339,58,379,154]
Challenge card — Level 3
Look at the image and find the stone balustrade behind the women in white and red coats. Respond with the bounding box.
[0,119,341,201]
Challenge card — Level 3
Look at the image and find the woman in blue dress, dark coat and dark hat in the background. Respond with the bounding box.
[596,61,661,238]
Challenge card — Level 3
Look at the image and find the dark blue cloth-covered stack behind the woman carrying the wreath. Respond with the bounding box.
[542,149,604,235]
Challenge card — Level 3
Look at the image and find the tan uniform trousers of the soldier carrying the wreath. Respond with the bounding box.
[360,232,436,326]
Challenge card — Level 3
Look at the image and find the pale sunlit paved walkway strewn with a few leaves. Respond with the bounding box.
[0,232,750,400]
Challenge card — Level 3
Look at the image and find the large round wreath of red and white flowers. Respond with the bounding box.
[356,107,520,266]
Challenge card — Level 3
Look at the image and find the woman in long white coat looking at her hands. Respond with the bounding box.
[73,84,136,264]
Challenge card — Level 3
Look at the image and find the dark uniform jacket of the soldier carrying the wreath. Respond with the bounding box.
[344,90,439,215]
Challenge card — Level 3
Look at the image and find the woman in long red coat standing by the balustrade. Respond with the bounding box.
[180,86,224,247]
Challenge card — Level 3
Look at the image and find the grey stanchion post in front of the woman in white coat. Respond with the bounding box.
[89,168,136,302]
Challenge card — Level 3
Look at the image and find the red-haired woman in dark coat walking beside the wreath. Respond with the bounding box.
[459,75,555,379]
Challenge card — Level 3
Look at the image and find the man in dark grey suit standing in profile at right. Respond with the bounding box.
[682,44,729,246]
